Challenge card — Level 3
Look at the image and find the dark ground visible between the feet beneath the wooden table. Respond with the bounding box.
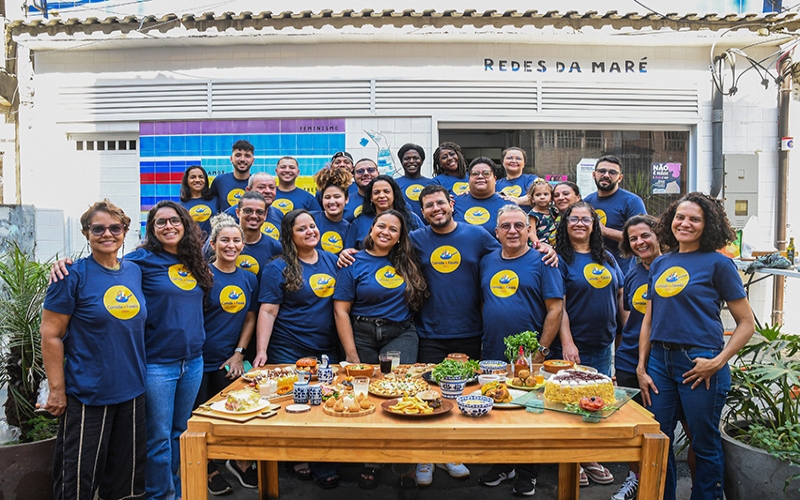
[214,462,691,500]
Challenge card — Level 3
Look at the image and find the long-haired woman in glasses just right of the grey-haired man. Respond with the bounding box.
[549,201,625,485]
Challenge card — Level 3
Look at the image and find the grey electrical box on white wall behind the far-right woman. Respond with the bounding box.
[724,154,759,229]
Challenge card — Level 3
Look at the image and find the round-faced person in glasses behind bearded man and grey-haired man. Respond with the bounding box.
[454,157,508,236]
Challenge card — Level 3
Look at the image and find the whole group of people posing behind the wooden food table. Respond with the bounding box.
[41,141,753,500]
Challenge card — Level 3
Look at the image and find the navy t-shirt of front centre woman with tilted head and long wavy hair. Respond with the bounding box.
[333,251,413,323]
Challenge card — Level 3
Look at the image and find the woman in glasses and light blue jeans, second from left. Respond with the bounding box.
[51,201,214,499]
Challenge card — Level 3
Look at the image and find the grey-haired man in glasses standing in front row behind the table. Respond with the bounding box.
[478,205,564,496]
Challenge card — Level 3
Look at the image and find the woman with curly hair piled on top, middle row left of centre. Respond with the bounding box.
[311,168,353,255]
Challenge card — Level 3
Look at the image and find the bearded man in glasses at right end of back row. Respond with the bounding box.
[584,155,647,273]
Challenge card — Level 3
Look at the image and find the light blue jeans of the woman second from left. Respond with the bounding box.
[145,356,203,500]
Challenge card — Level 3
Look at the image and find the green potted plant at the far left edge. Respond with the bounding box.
[0,243,57,498]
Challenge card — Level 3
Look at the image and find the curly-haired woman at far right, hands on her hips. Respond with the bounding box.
[636,192,755,500]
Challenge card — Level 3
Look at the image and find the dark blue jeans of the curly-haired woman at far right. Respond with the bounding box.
[647,342,731,500]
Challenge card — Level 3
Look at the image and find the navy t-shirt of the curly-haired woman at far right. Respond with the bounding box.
[646,251,746,349]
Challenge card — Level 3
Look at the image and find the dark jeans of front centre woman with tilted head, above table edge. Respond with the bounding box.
[352,318,419,365]
